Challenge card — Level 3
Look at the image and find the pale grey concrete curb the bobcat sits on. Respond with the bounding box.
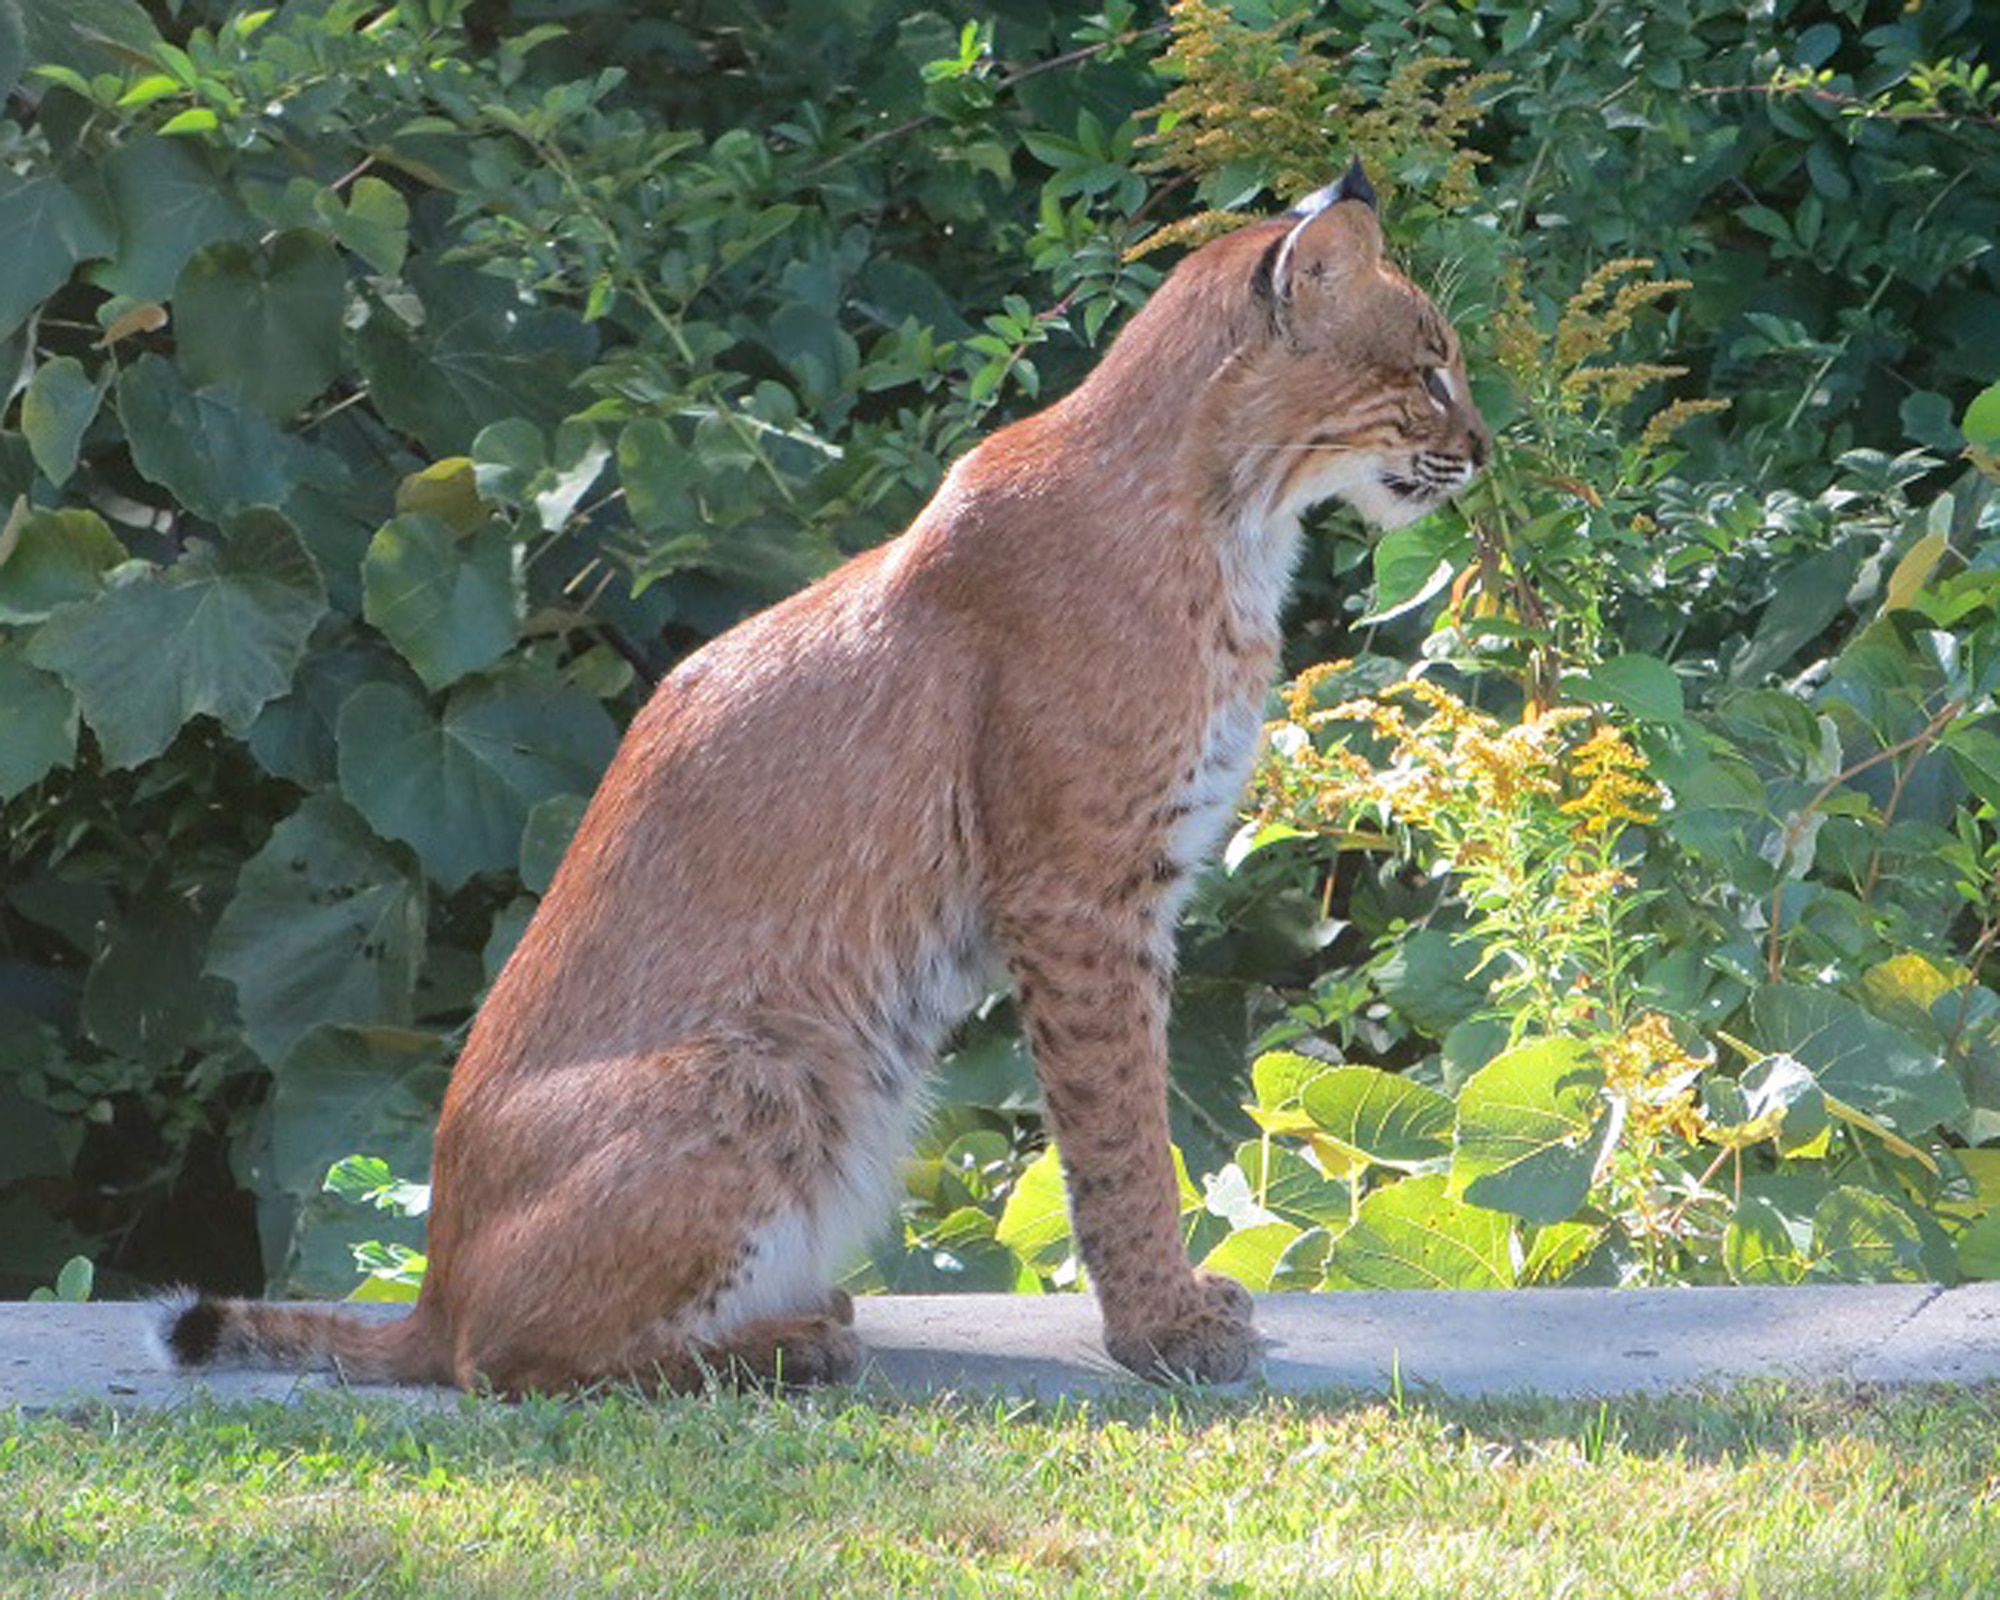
[0,1284,2000,1412]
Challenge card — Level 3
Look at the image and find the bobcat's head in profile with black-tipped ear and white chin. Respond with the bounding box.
[1210,162,1492,528]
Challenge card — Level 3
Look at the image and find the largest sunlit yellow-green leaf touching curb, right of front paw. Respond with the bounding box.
[1326,1174,1518,1288]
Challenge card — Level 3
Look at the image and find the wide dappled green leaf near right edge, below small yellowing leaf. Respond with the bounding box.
[1750,984,1966,1138]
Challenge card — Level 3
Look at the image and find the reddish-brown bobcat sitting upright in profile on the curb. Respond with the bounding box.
[164,162,1490,1394]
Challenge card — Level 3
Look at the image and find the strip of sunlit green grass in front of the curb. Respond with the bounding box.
[0,1386,2000,1600]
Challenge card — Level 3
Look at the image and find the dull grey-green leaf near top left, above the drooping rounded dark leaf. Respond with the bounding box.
[90,134,250,302]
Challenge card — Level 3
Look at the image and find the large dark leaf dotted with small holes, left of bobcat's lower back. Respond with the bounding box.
[208,794,424,1072]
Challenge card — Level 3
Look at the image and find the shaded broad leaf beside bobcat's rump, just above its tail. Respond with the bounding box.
[256,1028,446,1296]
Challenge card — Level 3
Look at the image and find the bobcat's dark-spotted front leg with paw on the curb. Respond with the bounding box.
[1004,890,1258,1382]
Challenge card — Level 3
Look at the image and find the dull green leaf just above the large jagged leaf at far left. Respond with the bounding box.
[116,356,302,522]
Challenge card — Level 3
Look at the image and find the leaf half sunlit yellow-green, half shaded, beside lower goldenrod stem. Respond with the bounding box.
[1452,1038,1612,1224]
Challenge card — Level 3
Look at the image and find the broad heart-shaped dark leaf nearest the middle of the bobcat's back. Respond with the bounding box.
[338,674,618,890]
